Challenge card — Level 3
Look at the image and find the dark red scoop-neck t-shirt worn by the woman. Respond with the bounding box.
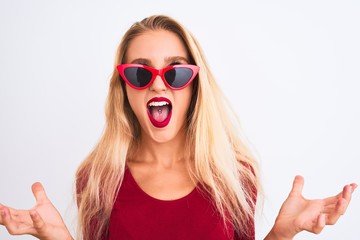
[108,169,255,240]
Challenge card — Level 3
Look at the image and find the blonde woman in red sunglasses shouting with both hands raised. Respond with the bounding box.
[0,16,357,240]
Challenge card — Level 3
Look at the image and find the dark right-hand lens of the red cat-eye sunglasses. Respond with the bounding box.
[164,67,193,88]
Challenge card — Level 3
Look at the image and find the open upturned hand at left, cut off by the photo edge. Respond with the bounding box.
[0,182,73,240]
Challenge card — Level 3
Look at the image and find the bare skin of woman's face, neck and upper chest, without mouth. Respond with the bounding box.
[126,30,195,200]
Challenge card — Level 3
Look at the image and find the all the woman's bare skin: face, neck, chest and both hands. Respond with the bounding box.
[0,31,357,240]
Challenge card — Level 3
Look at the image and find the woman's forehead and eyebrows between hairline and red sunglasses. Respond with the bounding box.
[126,30,188,64]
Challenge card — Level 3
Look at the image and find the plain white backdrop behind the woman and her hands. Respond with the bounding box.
[0,0,360,240]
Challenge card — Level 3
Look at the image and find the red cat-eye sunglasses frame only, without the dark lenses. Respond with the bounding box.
[116,64,200,90]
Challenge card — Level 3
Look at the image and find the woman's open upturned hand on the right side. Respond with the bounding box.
[265,176,357,240]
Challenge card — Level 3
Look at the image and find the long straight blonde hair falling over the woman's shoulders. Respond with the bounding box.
[76,15,260,240]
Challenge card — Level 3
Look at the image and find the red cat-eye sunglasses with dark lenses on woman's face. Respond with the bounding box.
[117,64,200,90]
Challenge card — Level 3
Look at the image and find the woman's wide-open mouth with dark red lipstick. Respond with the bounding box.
[147,97,172,128]
